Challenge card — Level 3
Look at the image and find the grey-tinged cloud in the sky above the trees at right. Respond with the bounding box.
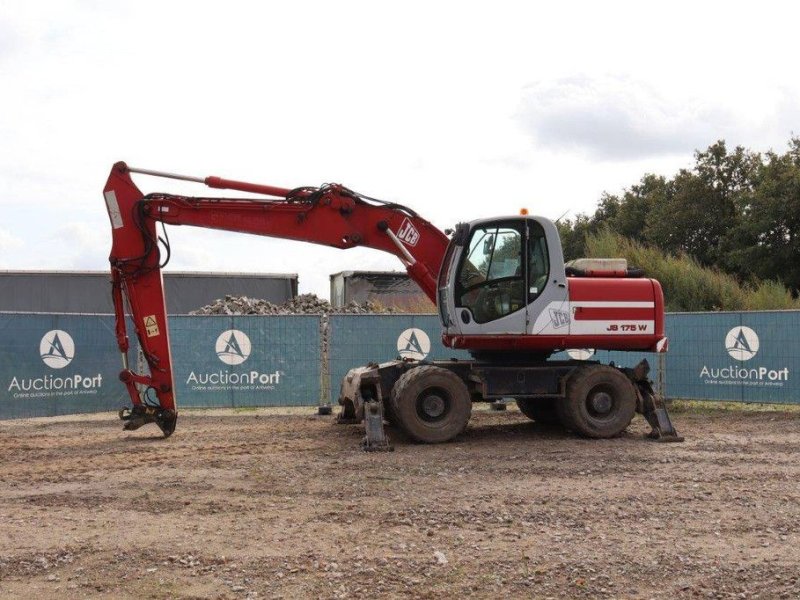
[518,76,800,161]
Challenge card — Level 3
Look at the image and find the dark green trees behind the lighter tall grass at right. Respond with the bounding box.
[558,137,800,297]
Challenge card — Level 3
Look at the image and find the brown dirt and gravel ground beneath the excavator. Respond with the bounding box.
[0,408,800,599]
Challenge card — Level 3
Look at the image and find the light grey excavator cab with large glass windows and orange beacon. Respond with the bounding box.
[439,217,569,335]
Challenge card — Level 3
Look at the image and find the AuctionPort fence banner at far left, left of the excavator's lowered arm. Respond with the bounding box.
[0,313,126,418]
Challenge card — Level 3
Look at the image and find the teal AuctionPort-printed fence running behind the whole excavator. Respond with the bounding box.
[0,311,800,418]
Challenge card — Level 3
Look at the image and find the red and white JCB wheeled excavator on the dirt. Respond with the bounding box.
[104,162,682,449]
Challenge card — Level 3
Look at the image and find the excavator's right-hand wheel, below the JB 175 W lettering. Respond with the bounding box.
[556,365,636,438]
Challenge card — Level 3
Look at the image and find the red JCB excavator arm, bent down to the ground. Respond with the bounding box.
[103,162,449,436]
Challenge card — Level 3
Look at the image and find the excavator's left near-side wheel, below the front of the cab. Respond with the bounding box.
[390,365,472,444]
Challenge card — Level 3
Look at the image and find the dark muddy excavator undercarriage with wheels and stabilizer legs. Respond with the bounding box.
[337,360,684,450]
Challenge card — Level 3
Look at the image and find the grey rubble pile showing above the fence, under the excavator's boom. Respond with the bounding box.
[189,294,397,315]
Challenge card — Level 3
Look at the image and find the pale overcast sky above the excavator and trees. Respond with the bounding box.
[0,0,800,297]
